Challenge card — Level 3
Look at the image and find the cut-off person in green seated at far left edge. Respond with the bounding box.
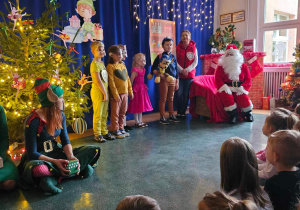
[0,105,18,191]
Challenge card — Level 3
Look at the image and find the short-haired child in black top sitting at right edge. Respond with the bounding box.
[265,130,300,210]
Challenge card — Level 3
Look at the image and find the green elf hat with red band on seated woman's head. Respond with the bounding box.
[34,77,64,107]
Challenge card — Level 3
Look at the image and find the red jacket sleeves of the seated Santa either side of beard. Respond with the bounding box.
[215,63,252,91]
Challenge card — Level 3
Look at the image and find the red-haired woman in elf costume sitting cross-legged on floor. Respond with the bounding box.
[18,78,100,194]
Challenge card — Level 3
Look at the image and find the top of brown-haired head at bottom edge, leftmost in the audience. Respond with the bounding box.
[116,195,160,210]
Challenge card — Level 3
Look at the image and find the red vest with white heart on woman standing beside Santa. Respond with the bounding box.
[176,40,197,79]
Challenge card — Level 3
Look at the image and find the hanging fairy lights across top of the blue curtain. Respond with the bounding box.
[133,0,214,30]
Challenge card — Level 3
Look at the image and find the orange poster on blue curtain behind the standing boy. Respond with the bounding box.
[149,18,176,65]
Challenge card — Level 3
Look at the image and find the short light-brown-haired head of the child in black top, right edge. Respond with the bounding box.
[268,130,300,167]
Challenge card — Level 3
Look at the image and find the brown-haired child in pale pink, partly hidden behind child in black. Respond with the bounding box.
[256,108,299,180]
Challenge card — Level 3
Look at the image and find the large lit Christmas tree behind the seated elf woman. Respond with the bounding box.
[0,0,89,141]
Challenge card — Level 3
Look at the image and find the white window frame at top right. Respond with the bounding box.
[257,0,300,63]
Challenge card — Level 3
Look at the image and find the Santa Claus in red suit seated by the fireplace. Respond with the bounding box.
[215,45,254,124]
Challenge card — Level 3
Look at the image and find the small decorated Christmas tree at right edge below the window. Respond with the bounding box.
[281,43,300,108]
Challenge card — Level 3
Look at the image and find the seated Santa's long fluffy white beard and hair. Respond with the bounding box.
[219,49,244,81]
